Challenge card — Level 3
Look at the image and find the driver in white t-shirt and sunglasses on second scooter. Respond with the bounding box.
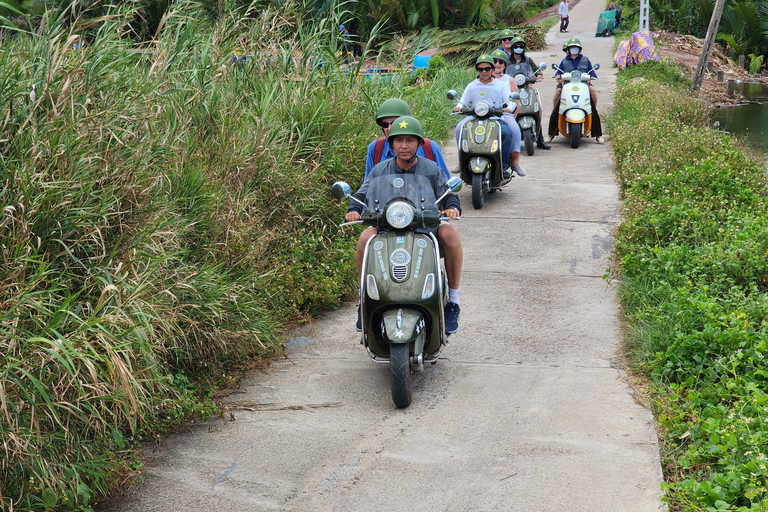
[453,54,525,179]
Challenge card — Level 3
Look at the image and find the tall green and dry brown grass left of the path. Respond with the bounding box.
[0,0,464,511]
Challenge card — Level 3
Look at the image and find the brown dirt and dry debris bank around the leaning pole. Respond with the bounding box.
[652,31,768,106]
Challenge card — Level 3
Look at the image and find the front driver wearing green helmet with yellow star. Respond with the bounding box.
[344,116,464,334]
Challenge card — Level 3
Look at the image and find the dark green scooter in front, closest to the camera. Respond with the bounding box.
[331,174,462,408]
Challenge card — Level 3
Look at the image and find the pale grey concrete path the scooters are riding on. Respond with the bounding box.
[99,0,662,512]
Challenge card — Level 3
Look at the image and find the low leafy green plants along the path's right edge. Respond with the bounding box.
[608,62,768,512]
